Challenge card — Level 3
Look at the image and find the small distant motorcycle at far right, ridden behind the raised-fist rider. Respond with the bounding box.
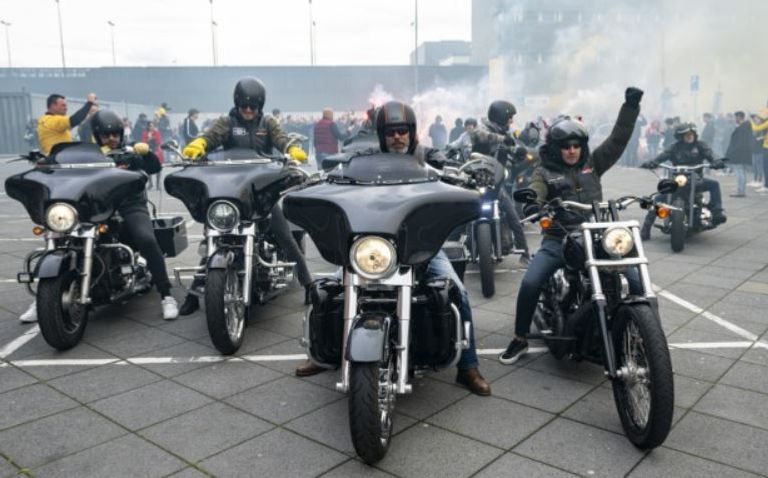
[655,164,728,252]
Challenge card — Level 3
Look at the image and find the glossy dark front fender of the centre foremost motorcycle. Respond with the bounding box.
[346,313,391,362]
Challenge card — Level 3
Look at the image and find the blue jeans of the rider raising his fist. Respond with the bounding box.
[515,237,643,338]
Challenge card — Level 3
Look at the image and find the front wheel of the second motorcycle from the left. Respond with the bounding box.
[205,267,248,355]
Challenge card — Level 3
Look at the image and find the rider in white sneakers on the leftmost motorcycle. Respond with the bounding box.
[21,110,179,323]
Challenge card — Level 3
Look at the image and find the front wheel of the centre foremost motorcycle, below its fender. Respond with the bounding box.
[349,354,395,465]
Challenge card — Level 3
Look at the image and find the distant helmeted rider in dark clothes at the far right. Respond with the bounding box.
[640,123,727,240]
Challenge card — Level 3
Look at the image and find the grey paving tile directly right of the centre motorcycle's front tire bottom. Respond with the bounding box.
[377,423,502,477]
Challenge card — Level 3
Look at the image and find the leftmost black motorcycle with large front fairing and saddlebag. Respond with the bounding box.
[5,143,187,350]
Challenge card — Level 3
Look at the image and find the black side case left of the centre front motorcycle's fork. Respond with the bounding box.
[304,279,344,367]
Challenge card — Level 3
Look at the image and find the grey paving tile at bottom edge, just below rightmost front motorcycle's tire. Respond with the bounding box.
[629,447,758,478]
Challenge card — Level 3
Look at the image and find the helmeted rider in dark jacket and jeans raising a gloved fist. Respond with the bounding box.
[499,87,643,364]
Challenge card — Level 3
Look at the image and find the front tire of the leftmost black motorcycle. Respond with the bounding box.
[37,271,89,350]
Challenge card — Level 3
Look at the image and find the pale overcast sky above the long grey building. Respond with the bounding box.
[0,0,472,67]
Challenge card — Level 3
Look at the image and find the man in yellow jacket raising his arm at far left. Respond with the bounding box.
[37,93,96,154]
